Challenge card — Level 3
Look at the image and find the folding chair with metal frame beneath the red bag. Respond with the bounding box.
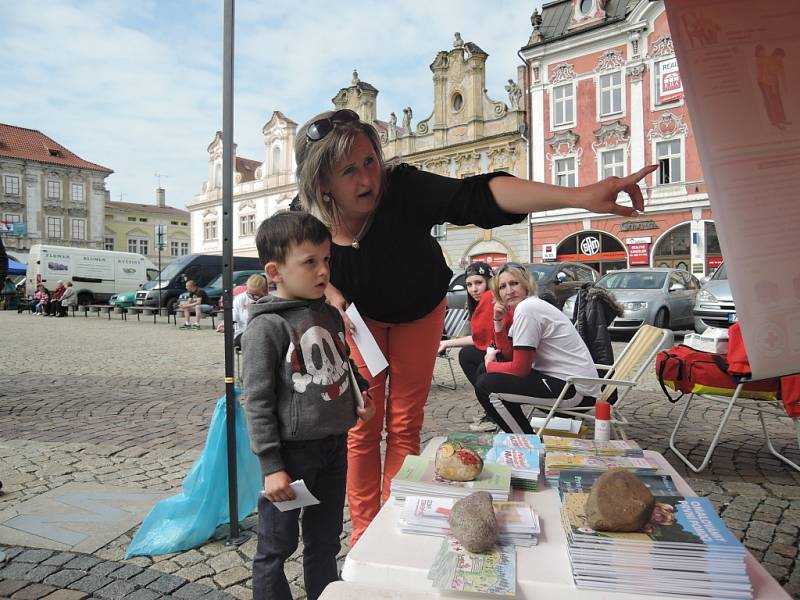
[669,380,800,473]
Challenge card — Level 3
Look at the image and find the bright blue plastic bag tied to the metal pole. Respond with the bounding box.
[125,389,263,558]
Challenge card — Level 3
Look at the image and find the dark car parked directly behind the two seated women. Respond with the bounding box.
[447,262,600,308]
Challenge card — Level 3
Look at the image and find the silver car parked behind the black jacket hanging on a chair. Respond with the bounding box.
[563,268,700,331]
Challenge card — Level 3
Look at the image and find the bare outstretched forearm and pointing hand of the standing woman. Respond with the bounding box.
[489,165,658,217]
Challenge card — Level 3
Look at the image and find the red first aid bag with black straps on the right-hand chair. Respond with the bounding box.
[656,344,778,402]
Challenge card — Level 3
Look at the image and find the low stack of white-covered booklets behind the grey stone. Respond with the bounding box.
[399,496,540,546]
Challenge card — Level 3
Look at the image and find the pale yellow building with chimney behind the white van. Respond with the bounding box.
[103,187,191,267]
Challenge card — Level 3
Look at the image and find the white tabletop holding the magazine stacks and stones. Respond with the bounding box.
[340,437,789,600]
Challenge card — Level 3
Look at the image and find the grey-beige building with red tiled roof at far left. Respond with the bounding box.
[0,124,113,260]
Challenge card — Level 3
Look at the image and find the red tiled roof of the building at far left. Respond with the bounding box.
[0,123,114,175]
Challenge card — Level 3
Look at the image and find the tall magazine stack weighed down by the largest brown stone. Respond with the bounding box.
[561,492,752,599]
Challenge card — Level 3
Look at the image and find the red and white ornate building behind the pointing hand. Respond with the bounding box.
[520,0,722,276]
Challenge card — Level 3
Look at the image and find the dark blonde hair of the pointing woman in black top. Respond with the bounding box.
[294,110,386,227]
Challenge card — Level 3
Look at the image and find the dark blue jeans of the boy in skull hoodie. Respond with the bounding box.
[253,434,347,600]
